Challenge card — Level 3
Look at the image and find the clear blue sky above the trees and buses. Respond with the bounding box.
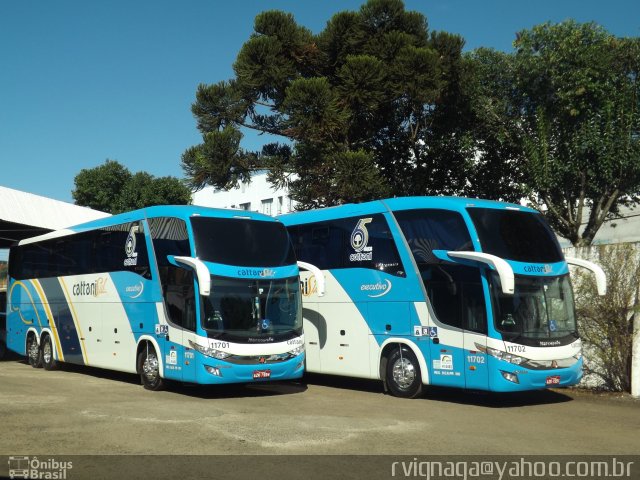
[0,0,640,202]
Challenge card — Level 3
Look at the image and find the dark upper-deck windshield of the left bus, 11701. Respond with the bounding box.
[191,217,296,267]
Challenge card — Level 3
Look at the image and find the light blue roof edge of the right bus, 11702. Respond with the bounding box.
[278,197,537,225]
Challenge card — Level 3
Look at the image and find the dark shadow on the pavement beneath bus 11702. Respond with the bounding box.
[304,374,573,408]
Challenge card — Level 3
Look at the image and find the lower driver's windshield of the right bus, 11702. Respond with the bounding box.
[491,272,577,341]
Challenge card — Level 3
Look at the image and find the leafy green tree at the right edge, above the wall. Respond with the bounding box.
[469,21,640,246]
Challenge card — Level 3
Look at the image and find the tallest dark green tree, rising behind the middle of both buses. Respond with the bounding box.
[182,0,474,208]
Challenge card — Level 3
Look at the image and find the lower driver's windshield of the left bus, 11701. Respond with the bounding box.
[202,275,302,343]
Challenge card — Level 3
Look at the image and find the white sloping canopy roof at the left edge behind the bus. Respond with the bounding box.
[0,186,109,248]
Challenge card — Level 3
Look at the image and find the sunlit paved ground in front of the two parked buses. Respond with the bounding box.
[0,359,640,455]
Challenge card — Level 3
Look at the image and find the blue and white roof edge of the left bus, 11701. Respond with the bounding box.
[19,205,278,245]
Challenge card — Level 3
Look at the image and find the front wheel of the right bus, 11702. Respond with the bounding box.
[380,342,425,398]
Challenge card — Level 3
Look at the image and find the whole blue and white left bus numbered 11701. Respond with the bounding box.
[7,206,316,390]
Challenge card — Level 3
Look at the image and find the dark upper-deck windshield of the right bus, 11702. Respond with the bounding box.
[467,208,563,263]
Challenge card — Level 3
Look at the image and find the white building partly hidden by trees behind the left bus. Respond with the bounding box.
[192,172,295,216]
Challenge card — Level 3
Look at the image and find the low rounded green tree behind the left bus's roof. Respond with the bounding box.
[72,160,191,214]
